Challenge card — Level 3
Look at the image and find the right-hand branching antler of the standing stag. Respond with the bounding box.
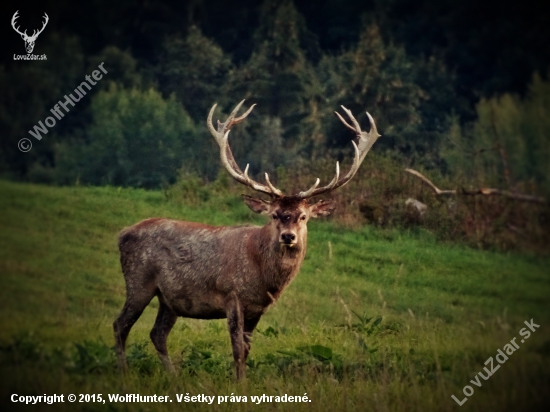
[296,106,380,199]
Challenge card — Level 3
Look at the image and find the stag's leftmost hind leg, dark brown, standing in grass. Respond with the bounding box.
[113,290,155,372]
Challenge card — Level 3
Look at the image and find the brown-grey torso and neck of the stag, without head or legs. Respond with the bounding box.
[119,219,305,319]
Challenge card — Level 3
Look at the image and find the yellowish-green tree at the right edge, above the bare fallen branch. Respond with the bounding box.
[442,74,550,195]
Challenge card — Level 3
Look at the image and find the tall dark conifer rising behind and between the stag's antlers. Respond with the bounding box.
[228,0,321,164]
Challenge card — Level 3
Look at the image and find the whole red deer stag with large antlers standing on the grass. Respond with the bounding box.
[113,100,380,379]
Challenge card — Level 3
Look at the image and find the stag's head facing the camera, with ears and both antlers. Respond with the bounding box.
[207,100,380,249]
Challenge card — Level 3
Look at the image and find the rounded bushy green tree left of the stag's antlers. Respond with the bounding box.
[56,84,199,188]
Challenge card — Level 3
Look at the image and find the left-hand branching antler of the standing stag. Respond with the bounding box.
[206,100,283,197]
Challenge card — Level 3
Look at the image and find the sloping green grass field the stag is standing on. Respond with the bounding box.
[0,181,550,412]
